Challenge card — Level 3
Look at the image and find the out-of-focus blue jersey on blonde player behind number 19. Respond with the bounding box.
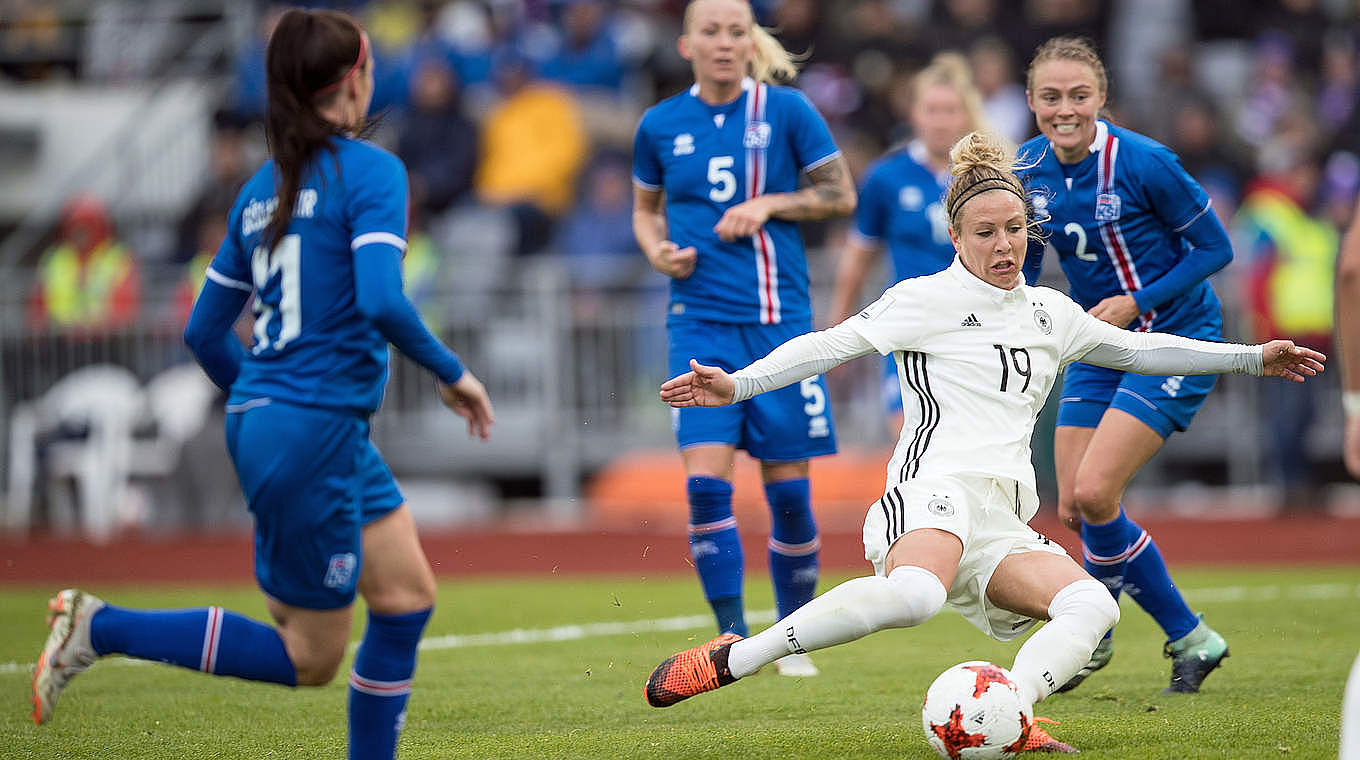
[854,141,953,286]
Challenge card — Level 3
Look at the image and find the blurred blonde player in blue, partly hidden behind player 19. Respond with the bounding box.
[831,53,983,431]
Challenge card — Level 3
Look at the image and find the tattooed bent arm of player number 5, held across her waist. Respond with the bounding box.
[713,155,855,242]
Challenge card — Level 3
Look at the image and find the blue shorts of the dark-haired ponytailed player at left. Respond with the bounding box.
[226,400,404,609]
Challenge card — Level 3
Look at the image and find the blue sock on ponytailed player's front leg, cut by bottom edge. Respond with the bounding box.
[350,608,434,760]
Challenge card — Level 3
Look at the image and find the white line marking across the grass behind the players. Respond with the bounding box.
[0,583,1360,676]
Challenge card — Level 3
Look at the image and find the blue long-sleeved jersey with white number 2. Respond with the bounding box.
[1019,121,1232,337]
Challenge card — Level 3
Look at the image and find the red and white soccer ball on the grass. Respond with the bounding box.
[921,661,1034,760]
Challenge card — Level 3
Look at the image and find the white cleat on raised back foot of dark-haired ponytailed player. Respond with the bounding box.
[33,589,103,725]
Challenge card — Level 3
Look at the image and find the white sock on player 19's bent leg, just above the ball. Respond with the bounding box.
[1010,578,1119,703]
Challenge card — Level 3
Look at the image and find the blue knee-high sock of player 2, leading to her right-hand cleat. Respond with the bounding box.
[1081,507,1200,642]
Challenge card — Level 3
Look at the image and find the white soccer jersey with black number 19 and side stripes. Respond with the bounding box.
[846,258,1089,511]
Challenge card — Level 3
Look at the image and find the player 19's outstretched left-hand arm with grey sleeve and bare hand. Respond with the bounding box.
[661,322,874,407]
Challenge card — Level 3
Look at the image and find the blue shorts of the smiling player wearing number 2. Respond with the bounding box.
[1057,363,1219,441]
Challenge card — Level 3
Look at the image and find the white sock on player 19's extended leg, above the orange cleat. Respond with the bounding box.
[728,566,946,678]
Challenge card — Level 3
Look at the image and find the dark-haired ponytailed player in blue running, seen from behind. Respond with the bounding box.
[33,10,492,759]
